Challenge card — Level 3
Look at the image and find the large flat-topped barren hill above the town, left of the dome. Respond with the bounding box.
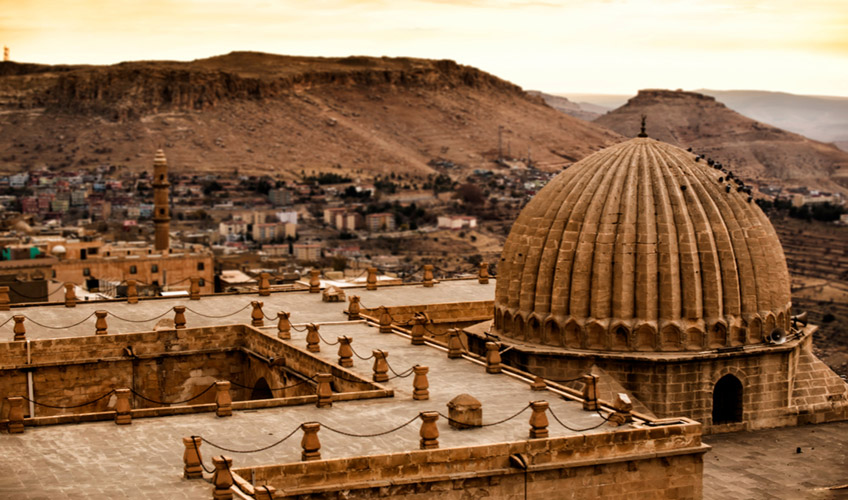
[0,52,620,177]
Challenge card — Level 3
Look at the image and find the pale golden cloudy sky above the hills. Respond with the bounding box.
[0,0,848,95]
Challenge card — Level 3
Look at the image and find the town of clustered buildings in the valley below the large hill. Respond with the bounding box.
[0,148,565,302]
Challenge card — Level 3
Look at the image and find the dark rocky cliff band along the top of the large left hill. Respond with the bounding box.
[0,52,522,120]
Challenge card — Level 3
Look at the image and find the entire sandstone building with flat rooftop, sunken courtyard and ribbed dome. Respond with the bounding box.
[0,142,848,500]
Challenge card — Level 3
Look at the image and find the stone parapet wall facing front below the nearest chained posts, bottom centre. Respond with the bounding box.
[235,421,709,499]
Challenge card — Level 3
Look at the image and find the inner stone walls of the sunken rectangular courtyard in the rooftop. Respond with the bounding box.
[0,325,380,419]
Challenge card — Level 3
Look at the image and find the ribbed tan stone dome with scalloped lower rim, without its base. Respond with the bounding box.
[494,138,791,351]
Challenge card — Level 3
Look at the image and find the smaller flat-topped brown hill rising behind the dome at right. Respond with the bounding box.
[594,90,848,192]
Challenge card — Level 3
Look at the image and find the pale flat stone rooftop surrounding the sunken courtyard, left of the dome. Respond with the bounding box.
[0,280,628,498]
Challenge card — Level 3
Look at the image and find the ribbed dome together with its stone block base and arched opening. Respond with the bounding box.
[472,137,848,432]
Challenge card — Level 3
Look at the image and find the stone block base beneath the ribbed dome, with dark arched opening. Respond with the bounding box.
[484,327,848,432]
